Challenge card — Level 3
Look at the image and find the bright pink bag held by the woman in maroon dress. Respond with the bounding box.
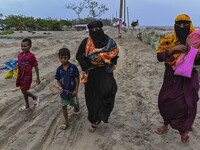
[174,47,198,78]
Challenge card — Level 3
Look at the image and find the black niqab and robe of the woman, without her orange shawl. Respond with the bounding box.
[76,21,117,132]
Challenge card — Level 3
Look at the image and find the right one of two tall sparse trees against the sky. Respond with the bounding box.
[84,0,109,18]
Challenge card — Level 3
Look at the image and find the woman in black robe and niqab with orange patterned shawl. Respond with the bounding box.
[76,21,119,132]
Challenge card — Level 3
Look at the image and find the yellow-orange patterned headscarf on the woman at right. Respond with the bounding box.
[157,14,195,66]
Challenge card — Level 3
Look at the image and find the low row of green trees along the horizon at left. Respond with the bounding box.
[0,13,115,31]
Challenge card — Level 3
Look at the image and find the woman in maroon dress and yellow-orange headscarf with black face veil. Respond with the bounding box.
[156,14,200,143]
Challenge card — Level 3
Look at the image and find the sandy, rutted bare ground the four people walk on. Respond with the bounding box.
[0,27,200,150]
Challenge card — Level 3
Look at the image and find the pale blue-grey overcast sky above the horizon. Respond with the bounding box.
[0,0,200,27]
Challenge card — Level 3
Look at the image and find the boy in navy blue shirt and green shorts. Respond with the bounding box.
[55,48,79,130]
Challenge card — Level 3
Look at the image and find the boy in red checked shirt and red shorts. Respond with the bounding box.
[16,39,40,111]
